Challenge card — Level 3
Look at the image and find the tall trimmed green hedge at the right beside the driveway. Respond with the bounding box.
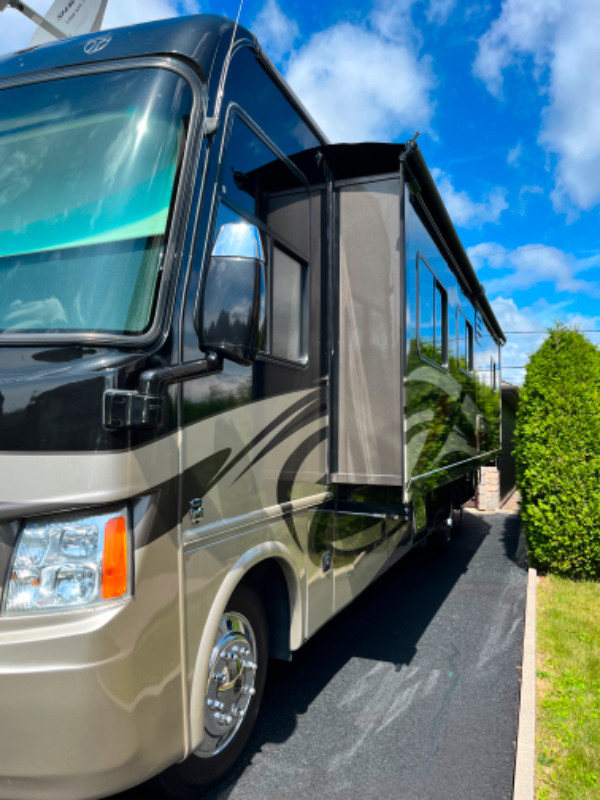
[515,326,600,578]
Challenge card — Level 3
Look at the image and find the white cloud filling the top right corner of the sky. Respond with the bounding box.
[473,0,600,216]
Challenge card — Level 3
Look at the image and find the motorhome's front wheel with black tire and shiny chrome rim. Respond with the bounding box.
[158,585,268,800]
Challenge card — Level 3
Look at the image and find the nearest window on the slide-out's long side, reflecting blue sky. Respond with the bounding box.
[417,257,448,366]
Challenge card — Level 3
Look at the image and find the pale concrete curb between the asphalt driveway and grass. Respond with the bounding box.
[513,568,537,800]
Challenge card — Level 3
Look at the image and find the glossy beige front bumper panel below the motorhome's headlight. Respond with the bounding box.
[0,534,184,800]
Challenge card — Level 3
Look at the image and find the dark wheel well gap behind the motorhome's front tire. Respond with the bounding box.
[242,558,292,661]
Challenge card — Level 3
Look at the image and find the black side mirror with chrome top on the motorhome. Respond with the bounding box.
[198,221,265,364]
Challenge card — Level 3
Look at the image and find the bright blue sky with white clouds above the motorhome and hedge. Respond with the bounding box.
[0,0,600,382]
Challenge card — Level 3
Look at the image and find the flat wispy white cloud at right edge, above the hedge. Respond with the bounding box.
[467,242,600,298]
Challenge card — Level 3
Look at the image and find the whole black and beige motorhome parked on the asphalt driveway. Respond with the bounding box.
[0,16,504,800]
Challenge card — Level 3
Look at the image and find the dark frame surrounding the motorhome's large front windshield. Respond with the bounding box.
[0,56,208,347]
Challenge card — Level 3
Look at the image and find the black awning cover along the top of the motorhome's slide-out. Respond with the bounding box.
[321,142,506,345]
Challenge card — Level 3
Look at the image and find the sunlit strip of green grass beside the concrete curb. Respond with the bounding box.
[536,577,600,800]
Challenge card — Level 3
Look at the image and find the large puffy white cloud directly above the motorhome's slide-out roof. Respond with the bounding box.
[286,3,434,142]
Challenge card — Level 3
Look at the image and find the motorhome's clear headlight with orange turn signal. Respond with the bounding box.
[4,508,131,615]
